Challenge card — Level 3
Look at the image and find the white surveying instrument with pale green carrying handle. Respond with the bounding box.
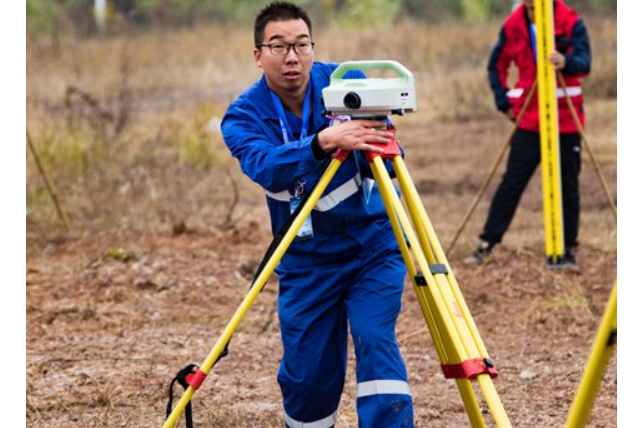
[323,60,417,119]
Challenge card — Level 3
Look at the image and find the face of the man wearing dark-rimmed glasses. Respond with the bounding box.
[254,19,314,96]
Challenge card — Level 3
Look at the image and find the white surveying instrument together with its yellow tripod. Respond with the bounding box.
[163,61,511,428]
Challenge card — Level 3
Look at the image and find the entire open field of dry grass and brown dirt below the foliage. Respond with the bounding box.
[26,17,617,428]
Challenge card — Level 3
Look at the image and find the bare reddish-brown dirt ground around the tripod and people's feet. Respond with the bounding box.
[26,106,617,428]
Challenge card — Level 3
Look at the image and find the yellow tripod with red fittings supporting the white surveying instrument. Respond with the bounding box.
[163,129,511,428]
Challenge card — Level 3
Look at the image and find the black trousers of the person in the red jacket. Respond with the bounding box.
[479,129,582,249]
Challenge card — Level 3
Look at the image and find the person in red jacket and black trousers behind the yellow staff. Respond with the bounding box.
[465,0,591,271]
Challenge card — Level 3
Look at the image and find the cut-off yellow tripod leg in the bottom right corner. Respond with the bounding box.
[566,282,617,428]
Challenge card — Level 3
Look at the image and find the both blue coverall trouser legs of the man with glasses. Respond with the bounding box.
[278,244,413,428]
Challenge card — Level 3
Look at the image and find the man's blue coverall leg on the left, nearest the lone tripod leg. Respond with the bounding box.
[277,266,347,427]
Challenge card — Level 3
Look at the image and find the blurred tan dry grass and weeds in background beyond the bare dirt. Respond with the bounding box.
[26,0,617,247]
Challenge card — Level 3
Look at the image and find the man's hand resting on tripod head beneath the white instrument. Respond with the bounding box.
[317,120,394,153]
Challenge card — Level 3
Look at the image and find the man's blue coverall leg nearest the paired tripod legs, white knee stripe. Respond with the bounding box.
[346,247,413,428]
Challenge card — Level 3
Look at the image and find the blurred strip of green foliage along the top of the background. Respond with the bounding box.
[26,0,617,38]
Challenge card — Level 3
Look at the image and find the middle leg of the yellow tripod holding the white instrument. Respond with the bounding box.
[371,157,486,428]
